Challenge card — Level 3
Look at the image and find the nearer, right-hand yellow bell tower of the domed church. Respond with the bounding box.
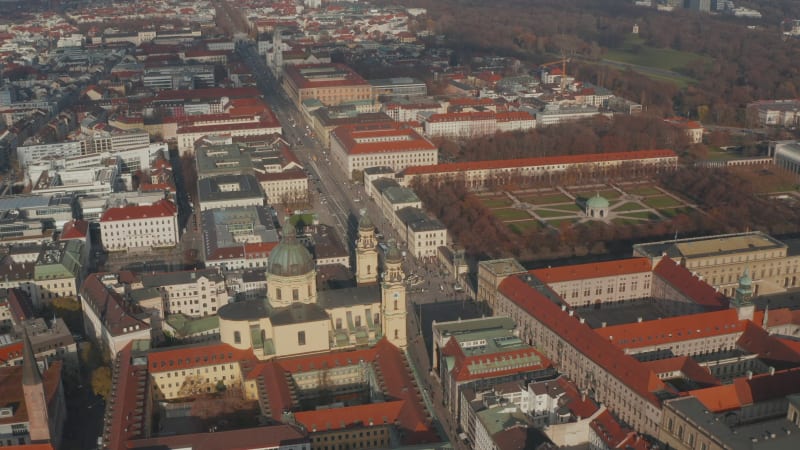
[381,241,408,348]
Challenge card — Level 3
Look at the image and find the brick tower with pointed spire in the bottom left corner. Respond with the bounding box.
[22,332,51,443]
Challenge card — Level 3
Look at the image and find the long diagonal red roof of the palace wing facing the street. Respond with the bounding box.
[499,276,666,406]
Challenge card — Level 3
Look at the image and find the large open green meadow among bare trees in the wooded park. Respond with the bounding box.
[605,36,708,72]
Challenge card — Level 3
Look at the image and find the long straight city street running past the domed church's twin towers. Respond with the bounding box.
[239,44,477,449]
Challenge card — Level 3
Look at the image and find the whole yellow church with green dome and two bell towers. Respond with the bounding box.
[218,215,407,359]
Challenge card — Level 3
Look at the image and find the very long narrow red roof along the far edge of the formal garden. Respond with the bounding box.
[405,150,678,175]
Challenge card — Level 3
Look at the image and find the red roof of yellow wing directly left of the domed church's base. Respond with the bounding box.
[147,344,255,373]
